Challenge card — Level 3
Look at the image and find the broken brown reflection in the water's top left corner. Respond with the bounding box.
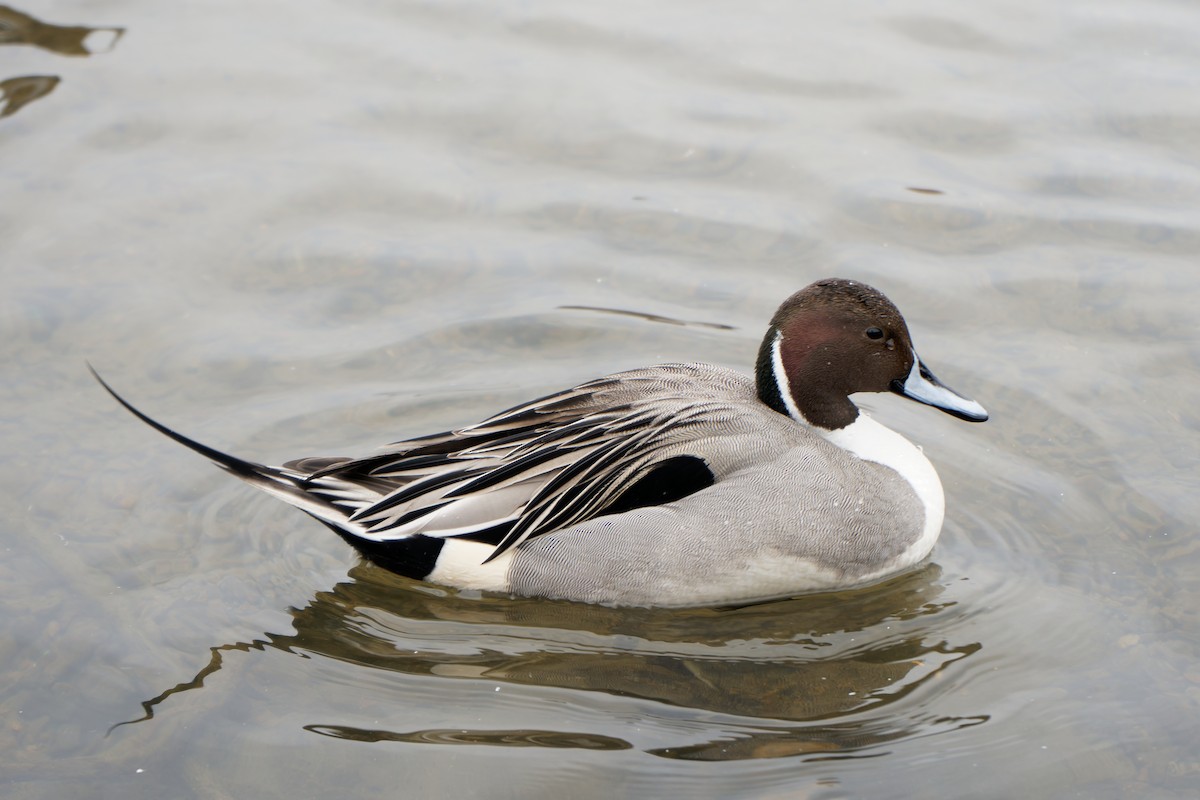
[0,6,125,118]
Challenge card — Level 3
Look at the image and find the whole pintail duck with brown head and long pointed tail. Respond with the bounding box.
[89,278,988,607]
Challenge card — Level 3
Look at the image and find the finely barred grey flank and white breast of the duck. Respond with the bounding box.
[477,365,943,604]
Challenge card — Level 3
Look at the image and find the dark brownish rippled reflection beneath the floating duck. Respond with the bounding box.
[121,565,986,760]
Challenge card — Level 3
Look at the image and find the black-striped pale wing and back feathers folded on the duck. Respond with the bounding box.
[297,373,733,558]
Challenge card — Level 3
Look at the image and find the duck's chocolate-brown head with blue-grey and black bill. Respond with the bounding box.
[756,278,988,431]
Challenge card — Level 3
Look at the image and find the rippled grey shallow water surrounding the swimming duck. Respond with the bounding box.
[0,0,1200,799]
